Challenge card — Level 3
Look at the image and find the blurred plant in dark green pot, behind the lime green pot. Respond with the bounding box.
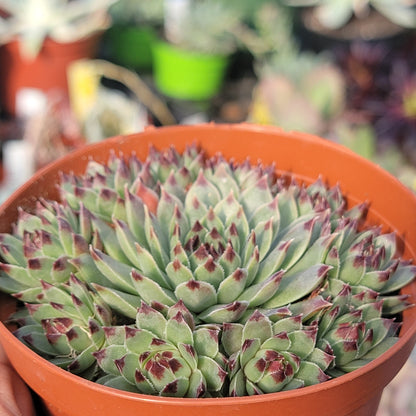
[105,0,164,71]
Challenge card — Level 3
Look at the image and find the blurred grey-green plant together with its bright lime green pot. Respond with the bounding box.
[154,0,242,101]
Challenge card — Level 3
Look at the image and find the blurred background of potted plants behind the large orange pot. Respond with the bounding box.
[0,0,416,416]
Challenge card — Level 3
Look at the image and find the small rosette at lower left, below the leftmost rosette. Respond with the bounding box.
[13,275,112,378]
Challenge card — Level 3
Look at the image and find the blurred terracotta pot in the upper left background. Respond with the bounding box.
[0,32,101,116]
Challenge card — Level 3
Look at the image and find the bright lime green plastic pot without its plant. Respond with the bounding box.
[153,42,228,101]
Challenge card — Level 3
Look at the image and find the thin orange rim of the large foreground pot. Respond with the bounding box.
[0,123,416,407]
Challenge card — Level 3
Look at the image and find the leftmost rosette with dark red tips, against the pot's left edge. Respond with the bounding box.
[0,200,92,303]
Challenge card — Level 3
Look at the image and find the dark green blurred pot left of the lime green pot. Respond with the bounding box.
[105,25,157,70]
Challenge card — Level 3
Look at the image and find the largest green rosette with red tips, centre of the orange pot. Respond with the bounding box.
[56,148,343,324]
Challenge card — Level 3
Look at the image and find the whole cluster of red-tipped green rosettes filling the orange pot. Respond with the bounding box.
[0,146,416,397]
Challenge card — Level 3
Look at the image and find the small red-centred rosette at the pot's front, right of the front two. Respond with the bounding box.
[222,311,334,396]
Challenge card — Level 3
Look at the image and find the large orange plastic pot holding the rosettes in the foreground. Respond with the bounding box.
[0,124,416,416]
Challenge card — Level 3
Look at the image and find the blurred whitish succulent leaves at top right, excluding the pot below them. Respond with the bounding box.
[284,0,416,29]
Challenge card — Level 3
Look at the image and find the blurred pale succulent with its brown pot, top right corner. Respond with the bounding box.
[284,0,416,41]
